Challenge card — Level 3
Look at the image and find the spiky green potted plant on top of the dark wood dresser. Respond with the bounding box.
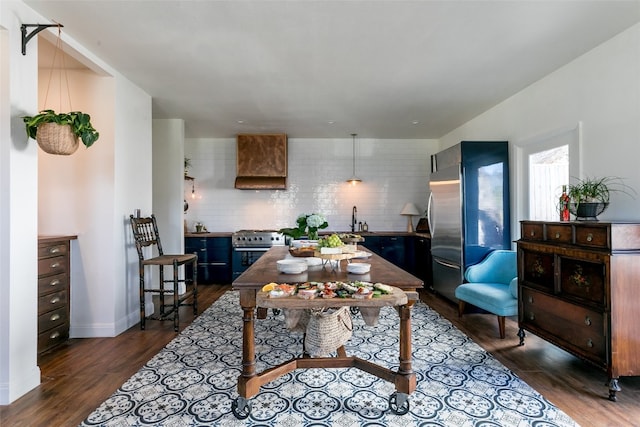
[568,176,630,221]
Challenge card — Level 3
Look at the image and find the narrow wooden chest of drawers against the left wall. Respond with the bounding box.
[38,236,76,355]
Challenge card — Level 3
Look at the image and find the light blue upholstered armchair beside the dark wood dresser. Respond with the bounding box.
[456,250,518,338]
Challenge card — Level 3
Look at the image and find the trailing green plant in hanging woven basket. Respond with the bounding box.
[22,110,100,155]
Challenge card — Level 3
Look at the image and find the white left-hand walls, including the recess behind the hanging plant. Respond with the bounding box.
[0,1,153,404]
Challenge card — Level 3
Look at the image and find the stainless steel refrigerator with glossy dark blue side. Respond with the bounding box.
[427,141,511,302]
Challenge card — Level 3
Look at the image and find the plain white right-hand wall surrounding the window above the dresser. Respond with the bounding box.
[441,24,640,237]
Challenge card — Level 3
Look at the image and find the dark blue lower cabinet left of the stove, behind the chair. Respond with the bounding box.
[184,236,231,284]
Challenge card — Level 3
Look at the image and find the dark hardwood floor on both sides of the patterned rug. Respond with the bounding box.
[0,285,640,427]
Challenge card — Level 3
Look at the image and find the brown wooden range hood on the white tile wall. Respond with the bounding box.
[235,133,287,190]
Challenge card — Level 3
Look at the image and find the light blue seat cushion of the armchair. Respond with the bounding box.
[456,283,518,316]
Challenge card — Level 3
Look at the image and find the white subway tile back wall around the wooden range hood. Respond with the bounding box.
[184,138,437,231]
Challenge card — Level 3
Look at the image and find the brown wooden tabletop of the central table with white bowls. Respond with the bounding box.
[233,245,423,291]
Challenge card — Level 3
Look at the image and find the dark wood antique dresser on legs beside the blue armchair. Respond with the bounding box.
[517,221,640,401]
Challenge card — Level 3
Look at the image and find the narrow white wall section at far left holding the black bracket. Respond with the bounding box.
[0,1,46,404]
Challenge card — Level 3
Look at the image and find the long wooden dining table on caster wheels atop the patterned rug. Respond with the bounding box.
[232,245,423,419]
